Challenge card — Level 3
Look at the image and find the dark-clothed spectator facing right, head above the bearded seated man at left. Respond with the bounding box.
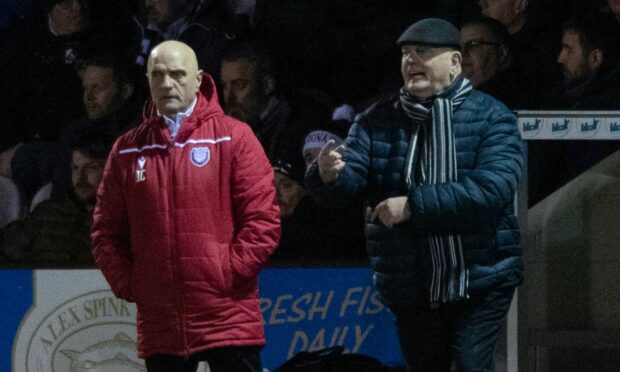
[0,56,141,199]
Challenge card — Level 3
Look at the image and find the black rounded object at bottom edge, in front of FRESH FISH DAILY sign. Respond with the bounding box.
[274,346,390,372]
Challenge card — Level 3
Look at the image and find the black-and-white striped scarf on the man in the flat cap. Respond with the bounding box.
[400,76,472,307]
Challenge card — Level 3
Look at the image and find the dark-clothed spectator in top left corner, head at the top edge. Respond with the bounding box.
[0,0,89,152]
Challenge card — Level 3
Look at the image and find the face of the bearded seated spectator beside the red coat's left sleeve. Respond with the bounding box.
[71,150,106,206]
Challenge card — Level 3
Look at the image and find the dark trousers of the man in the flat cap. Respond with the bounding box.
[396,288,514,372]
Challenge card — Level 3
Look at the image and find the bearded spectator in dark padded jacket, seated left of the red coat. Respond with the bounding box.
[0,136,111,266]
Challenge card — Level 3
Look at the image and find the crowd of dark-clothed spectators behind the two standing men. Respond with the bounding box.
[0,0,620,264]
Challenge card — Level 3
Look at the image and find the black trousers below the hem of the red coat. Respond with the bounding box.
[145,346,262,372]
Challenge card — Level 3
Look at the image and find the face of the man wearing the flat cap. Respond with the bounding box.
[400,45,461,98]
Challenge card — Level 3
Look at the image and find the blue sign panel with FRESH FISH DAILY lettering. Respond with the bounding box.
[260,269,401,368]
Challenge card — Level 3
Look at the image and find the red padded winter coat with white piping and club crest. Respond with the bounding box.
[92,76,280,357]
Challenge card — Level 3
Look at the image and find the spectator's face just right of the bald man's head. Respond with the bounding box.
[220,58,268,125]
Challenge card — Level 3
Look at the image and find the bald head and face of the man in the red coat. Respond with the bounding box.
[147,41,202,118]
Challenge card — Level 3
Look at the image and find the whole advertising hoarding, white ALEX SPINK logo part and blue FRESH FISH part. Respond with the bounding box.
[0,268,401,372]
